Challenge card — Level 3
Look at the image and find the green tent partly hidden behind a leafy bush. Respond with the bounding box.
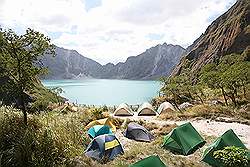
[202,129,247,167]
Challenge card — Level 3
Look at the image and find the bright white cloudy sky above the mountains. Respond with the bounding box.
[0,0,236,64]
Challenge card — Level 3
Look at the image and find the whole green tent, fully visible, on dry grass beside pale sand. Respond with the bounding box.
[163,122,205,155]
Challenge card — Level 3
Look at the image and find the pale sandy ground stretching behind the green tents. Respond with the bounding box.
[113,115,250,149]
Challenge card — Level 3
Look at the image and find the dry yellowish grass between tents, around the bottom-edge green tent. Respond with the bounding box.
[73,130,215,167]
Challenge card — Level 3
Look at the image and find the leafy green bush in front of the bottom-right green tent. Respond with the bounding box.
[214,146,248,167]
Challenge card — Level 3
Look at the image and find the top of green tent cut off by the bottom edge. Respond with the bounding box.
[129,155,167,167]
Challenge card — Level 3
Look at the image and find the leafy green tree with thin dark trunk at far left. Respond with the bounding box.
[0,29,54,125]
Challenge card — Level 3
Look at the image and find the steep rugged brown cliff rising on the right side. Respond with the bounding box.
[171,0,250,76]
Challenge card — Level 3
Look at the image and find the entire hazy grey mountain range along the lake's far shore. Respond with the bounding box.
[43,43,185,79]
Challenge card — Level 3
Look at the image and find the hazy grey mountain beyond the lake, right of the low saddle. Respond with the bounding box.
[102,43,185,79]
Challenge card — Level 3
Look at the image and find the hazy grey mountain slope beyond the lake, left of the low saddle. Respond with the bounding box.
[42,47,102,79]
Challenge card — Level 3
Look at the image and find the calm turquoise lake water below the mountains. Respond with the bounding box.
[42,79,161,106]
